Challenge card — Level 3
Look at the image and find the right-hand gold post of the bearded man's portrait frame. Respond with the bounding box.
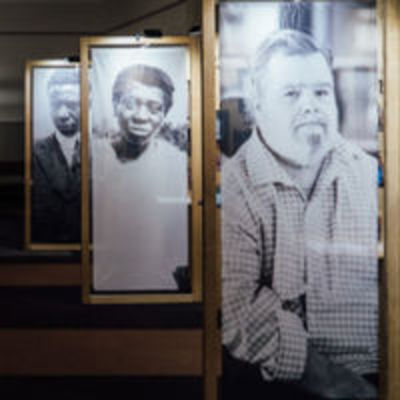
[378,0,400,400]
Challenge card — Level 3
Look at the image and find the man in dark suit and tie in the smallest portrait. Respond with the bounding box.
[32,68,81,243]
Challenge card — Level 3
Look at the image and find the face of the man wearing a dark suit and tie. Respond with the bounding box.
[49,83,80,137]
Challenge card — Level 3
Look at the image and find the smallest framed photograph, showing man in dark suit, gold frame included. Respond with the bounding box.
[25,60,81,250]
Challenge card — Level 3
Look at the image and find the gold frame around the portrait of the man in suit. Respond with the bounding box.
[24,60,81,251]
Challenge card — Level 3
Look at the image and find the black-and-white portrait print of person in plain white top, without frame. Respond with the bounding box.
[91,46,189,292]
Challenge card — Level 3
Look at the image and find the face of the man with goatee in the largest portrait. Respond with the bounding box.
[255,53,338,167]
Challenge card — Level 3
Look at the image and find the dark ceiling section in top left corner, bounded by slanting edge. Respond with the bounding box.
[0,0,181,36]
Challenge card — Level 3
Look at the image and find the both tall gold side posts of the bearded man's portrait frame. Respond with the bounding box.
[202,0,400,400]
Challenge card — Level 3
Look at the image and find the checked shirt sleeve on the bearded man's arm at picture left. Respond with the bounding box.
[222,152,307,380]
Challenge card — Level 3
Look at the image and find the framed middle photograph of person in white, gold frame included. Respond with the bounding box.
[81,37,202,303]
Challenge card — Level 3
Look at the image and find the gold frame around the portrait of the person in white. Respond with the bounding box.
[80,36,203,304]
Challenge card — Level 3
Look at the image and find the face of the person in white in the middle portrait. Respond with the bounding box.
[115,82,165,138]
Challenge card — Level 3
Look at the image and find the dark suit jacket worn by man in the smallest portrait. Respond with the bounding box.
[32,133,81,243]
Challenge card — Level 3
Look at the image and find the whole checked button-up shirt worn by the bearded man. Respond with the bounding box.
[222,133,378,380]
